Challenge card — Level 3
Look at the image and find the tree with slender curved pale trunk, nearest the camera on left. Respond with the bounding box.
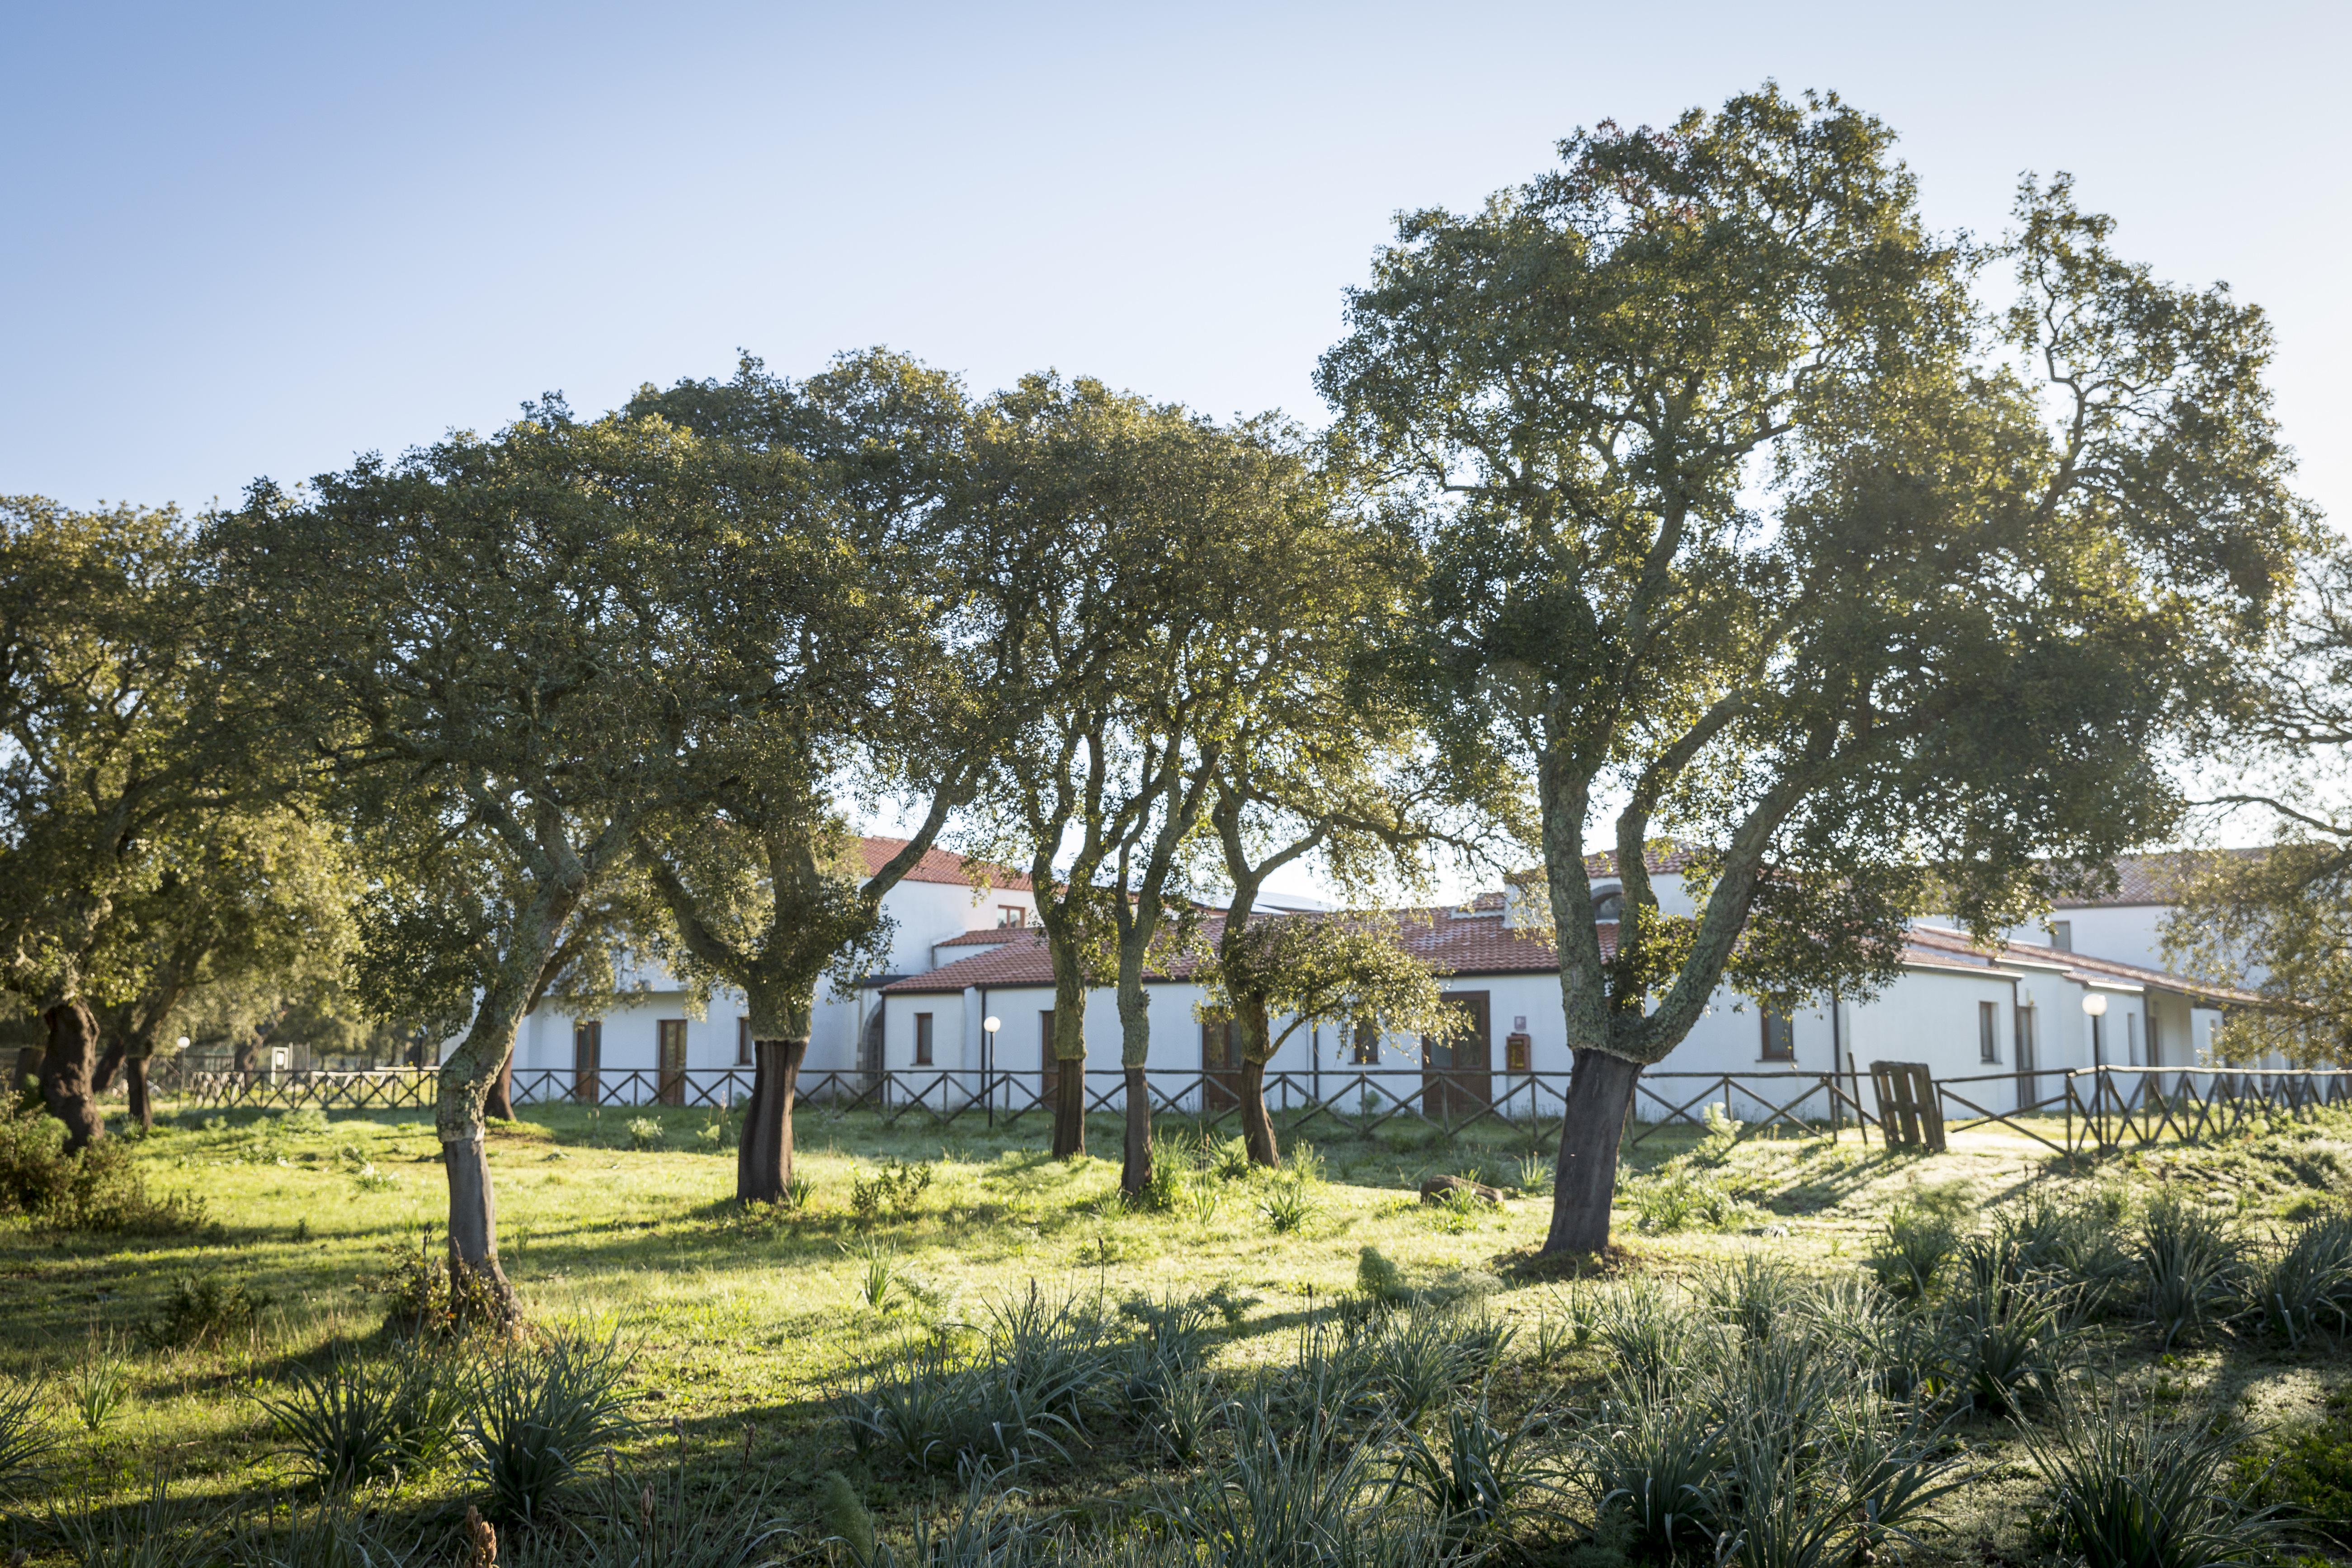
[212,397,837,1312]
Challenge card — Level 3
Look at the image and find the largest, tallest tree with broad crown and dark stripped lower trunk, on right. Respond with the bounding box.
[1320,87,2305,1251]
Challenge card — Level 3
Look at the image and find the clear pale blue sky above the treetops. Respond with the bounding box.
[0,2,2352,533]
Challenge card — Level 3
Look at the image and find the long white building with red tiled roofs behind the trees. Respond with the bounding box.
[496,839,2241,1119]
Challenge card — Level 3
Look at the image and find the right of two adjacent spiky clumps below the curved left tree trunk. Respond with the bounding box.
[466,1333,630,1523]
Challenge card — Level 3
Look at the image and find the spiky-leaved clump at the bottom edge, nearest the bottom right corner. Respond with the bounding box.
[2025,1406,2277,1568]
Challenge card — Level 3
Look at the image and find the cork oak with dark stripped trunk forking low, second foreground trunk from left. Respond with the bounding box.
[630,350,1002,1204]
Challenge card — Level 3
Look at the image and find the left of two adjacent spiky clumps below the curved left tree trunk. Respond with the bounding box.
[261,1345,466,1486]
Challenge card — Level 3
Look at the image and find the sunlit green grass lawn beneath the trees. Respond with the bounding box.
[0,1107,2352,1561]
